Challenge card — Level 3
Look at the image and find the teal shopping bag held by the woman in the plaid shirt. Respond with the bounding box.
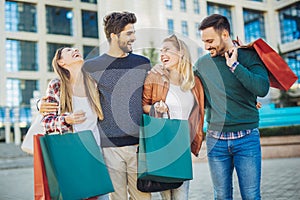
[44,130,114,200]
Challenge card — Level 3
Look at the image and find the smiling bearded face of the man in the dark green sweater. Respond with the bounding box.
[201,27,228,57]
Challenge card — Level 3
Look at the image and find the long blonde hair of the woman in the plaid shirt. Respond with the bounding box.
[52,47,103,120]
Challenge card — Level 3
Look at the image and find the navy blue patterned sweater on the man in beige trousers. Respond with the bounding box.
[83,54,151,147]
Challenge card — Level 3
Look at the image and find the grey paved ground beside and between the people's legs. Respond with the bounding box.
[0,158,300,200]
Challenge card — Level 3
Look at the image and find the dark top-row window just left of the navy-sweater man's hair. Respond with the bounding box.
[81,10,99,38]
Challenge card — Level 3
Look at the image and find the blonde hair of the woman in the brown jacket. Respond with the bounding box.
[163,35,195,91]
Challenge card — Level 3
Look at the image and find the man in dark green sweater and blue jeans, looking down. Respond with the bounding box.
[195,14,270,200]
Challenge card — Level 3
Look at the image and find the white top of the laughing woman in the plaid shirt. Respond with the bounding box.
[73,96,100,146]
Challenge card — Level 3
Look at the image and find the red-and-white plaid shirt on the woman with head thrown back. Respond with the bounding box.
[41,78,72,134]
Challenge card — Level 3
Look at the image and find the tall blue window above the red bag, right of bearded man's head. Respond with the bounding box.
[243,9,266,43]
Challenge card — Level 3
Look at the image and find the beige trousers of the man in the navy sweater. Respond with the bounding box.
[102,145,151,200]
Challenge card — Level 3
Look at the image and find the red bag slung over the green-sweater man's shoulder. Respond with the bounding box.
[241,38,298,90]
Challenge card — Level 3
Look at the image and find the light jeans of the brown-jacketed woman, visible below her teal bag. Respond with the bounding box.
[160,181,190,200]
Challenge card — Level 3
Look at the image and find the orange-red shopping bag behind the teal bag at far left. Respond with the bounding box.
[33,134,51,200]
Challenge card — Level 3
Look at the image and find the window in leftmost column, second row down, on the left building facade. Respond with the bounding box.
[5,39,38,72]
